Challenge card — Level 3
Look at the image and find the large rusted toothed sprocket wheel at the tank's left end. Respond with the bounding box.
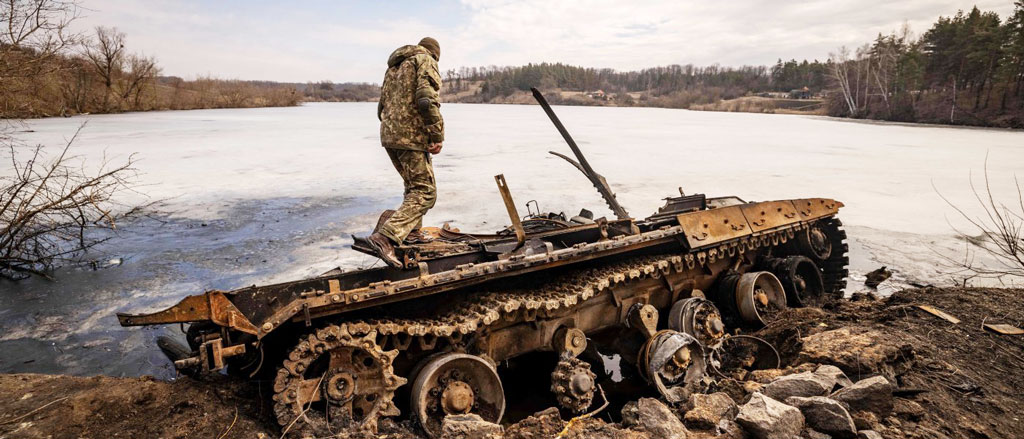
[273,325,407,437]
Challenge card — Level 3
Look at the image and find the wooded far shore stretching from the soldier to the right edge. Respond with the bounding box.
[444,0,1024,128]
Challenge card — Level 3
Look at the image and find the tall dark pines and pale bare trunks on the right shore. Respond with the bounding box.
[828,0,1024,128]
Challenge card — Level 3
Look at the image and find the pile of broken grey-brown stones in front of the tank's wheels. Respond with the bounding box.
[442,364,893,439]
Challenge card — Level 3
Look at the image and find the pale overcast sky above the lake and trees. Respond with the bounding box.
[70,0,1013,83]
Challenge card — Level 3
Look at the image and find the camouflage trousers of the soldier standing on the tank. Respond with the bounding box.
[380,148,437,244]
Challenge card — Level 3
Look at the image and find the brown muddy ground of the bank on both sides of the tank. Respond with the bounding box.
[0,289,1024,439]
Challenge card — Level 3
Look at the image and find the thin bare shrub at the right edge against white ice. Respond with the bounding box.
[936,158,1024,280]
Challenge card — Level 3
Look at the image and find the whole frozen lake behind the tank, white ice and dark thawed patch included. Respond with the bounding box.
[0,103,1024,377]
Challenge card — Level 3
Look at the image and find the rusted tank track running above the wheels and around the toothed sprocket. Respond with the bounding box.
[274,226,806,426]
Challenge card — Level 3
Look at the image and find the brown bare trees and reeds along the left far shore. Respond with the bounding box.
[0,0,301,119]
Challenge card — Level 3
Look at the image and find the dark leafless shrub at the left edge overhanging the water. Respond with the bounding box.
[0,123,140,278]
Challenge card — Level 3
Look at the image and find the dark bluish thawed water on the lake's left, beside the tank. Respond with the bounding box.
[0,199,380,378]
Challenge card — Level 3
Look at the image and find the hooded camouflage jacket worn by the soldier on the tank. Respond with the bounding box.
[377,46,444,150]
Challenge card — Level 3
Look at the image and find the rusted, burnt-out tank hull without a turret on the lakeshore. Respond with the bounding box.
[118,89,848,437]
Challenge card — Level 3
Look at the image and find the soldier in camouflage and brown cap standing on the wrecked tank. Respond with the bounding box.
[369,37,444,267]
